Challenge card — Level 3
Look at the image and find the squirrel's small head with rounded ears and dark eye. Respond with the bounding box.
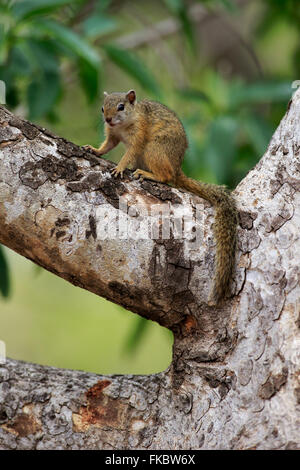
[102,90,136,127]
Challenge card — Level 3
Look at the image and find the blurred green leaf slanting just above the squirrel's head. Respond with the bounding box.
[104,45,160,96]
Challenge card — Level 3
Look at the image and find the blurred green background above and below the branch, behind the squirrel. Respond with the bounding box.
[0,0,300,373]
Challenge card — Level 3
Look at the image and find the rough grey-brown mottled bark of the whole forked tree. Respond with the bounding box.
[0,90,300,449]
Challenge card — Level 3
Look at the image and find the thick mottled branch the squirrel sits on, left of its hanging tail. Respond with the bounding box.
[0,104,233,358]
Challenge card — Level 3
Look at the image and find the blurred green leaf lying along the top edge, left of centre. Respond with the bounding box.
[12,0,78,21]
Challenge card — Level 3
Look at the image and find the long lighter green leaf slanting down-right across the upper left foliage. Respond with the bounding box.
[34,19,100,69]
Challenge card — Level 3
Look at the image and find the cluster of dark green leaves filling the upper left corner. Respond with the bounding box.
[0,0,101,120]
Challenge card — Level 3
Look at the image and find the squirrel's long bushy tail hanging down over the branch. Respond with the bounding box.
[176,172,237,305]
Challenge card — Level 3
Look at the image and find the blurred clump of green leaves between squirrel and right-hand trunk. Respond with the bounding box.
[177,77,292,188]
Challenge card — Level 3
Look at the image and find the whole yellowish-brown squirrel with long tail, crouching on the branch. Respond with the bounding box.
[84,90,237,306]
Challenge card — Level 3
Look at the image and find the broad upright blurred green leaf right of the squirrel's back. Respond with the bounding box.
[203,115,238,185]
